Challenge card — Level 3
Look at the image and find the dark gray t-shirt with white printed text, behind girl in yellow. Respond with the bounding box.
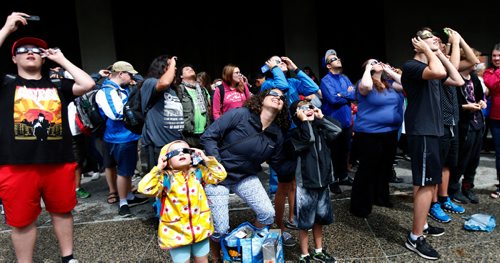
[141,78,184,148]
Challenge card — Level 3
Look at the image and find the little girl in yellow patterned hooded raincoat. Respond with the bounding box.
[138,140,227,262]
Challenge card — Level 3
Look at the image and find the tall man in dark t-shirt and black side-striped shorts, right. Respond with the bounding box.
[401,28,463,259]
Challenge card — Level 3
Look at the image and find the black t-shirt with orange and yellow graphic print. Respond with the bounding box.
[0,75,74,164]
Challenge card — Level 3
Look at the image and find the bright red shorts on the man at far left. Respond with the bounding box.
[0,163,77,227]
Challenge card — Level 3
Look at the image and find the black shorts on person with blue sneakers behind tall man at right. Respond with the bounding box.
[439,125,458,167]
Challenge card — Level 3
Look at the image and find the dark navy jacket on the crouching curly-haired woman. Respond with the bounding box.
[201,107,294,185]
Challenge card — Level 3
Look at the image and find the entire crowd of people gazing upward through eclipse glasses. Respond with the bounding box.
[0,12,500,263]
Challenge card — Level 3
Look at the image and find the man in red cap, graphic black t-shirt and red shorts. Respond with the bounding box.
[0,12,95,263]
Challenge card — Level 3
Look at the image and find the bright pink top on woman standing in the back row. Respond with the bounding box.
[212,82,251,120]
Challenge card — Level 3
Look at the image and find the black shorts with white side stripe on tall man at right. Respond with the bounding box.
[408,135,443,186]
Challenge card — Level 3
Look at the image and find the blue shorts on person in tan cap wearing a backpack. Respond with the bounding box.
[104,141,138,176]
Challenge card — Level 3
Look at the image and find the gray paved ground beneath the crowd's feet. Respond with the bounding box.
[0,154,500,262]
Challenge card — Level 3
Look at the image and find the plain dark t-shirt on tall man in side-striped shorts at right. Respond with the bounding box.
[401,59,444,136]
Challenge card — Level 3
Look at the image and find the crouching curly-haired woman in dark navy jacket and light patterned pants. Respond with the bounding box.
[201,88,293,262]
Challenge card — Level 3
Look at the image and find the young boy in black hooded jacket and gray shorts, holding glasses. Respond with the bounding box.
[290,100,342,262]
